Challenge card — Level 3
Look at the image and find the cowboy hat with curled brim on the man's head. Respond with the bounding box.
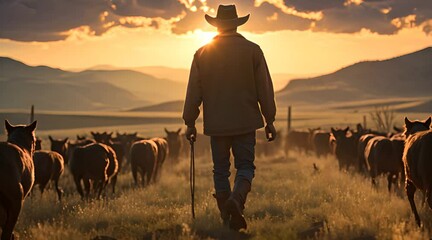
[205,5,250,29]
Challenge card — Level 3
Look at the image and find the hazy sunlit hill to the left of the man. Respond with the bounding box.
[0,57,186,111]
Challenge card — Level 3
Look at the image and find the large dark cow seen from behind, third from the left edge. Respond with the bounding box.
[69,143,110,200]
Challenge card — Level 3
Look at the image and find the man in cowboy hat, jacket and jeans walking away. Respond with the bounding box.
[183,5,276,230]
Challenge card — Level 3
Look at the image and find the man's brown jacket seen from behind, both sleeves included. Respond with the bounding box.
[183,33,276,136]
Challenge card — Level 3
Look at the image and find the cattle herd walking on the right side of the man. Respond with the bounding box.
[285,117,432,226]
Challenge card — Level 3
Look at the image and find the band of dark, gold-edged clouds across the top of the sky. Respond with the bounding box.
[0,0,432,42]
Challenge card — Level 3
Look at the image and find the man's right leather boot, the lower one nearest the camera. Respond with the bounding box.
[225,179,251,231]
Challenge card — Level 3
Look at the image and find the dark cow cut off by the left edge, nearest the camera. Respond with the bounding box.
[0,120,37,240]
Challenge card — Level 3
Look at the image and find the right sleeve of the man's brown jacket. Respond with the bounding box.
[254,48,276,124]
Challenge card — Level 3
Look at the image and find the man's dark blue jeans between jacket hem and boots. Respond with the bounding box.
[210,131,256,193]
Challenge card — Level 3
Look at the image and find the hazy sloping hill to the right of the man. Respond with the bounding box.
[276,47,432,106]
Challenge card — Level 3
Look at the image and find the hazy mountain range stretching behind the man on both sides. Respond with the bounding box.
[0,47,432,112]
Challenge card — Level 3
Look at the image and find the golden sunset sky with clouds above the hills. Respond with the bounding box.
[0,0,432,75]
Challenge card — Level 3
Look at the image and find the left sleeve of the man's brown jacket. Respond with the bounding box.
[183,55,202,127]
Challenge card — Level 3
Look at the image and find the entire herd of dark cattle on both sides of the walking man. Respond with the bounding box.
[0,118,432,240]
